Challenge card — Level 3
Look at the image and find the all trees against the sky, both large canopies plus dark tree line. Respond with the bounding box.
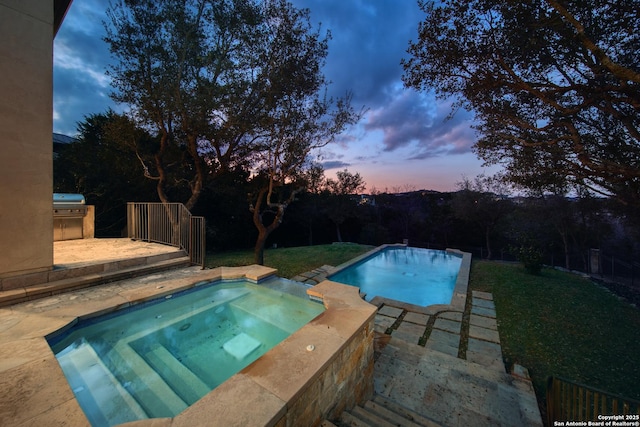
[54,0,640,276]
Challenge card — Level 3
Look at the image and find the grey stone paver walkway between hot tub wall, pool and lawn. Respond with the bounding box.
[293,266,542,427]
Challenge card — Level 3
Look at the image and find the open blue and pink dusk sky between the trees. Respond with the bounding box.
[53,0,496,191]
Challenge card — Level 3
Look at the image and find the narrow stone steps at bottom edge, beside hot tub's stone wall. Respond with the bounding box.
[338,395,440,427]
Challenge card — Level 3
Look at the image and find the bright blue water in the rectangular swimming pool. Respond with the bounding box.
[329,247,462,306]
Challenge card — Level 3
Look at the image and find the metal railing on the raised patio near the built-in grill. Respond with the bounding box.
[127,202,206,268]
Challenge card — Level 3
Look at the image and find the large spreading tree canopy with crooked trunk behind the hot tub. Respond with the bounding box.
[106,0,359,263]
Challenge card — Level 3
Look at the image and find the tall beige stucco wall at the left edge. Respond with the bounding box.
[0,0,53,276]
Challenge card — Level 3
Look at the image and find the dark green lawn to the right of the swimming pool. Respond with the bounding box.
[469,261,640,410]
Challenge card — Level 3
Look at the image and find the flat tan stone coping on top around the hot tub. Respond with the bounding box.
[0,265,376,427]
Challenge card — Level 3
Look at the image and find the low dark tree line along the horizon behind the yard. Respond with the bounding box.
[54,111,640,280]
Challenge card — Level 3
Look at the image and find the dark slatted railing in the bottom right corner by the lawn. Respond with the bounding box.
[547,377,640,426]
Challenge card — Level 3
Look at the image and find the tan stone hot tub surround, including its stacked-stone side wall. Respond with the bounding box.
[0,266,376,427]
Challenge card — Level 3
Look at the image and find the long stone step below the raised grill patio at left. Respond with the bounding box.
[0,256,190,307]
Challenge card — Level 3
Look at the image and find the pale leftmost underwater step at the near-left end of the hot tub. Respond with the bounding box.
[58,339,148,425]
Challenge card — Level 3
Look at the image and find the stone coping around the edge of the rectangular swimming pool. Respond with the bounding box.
[326,243,471,315]
